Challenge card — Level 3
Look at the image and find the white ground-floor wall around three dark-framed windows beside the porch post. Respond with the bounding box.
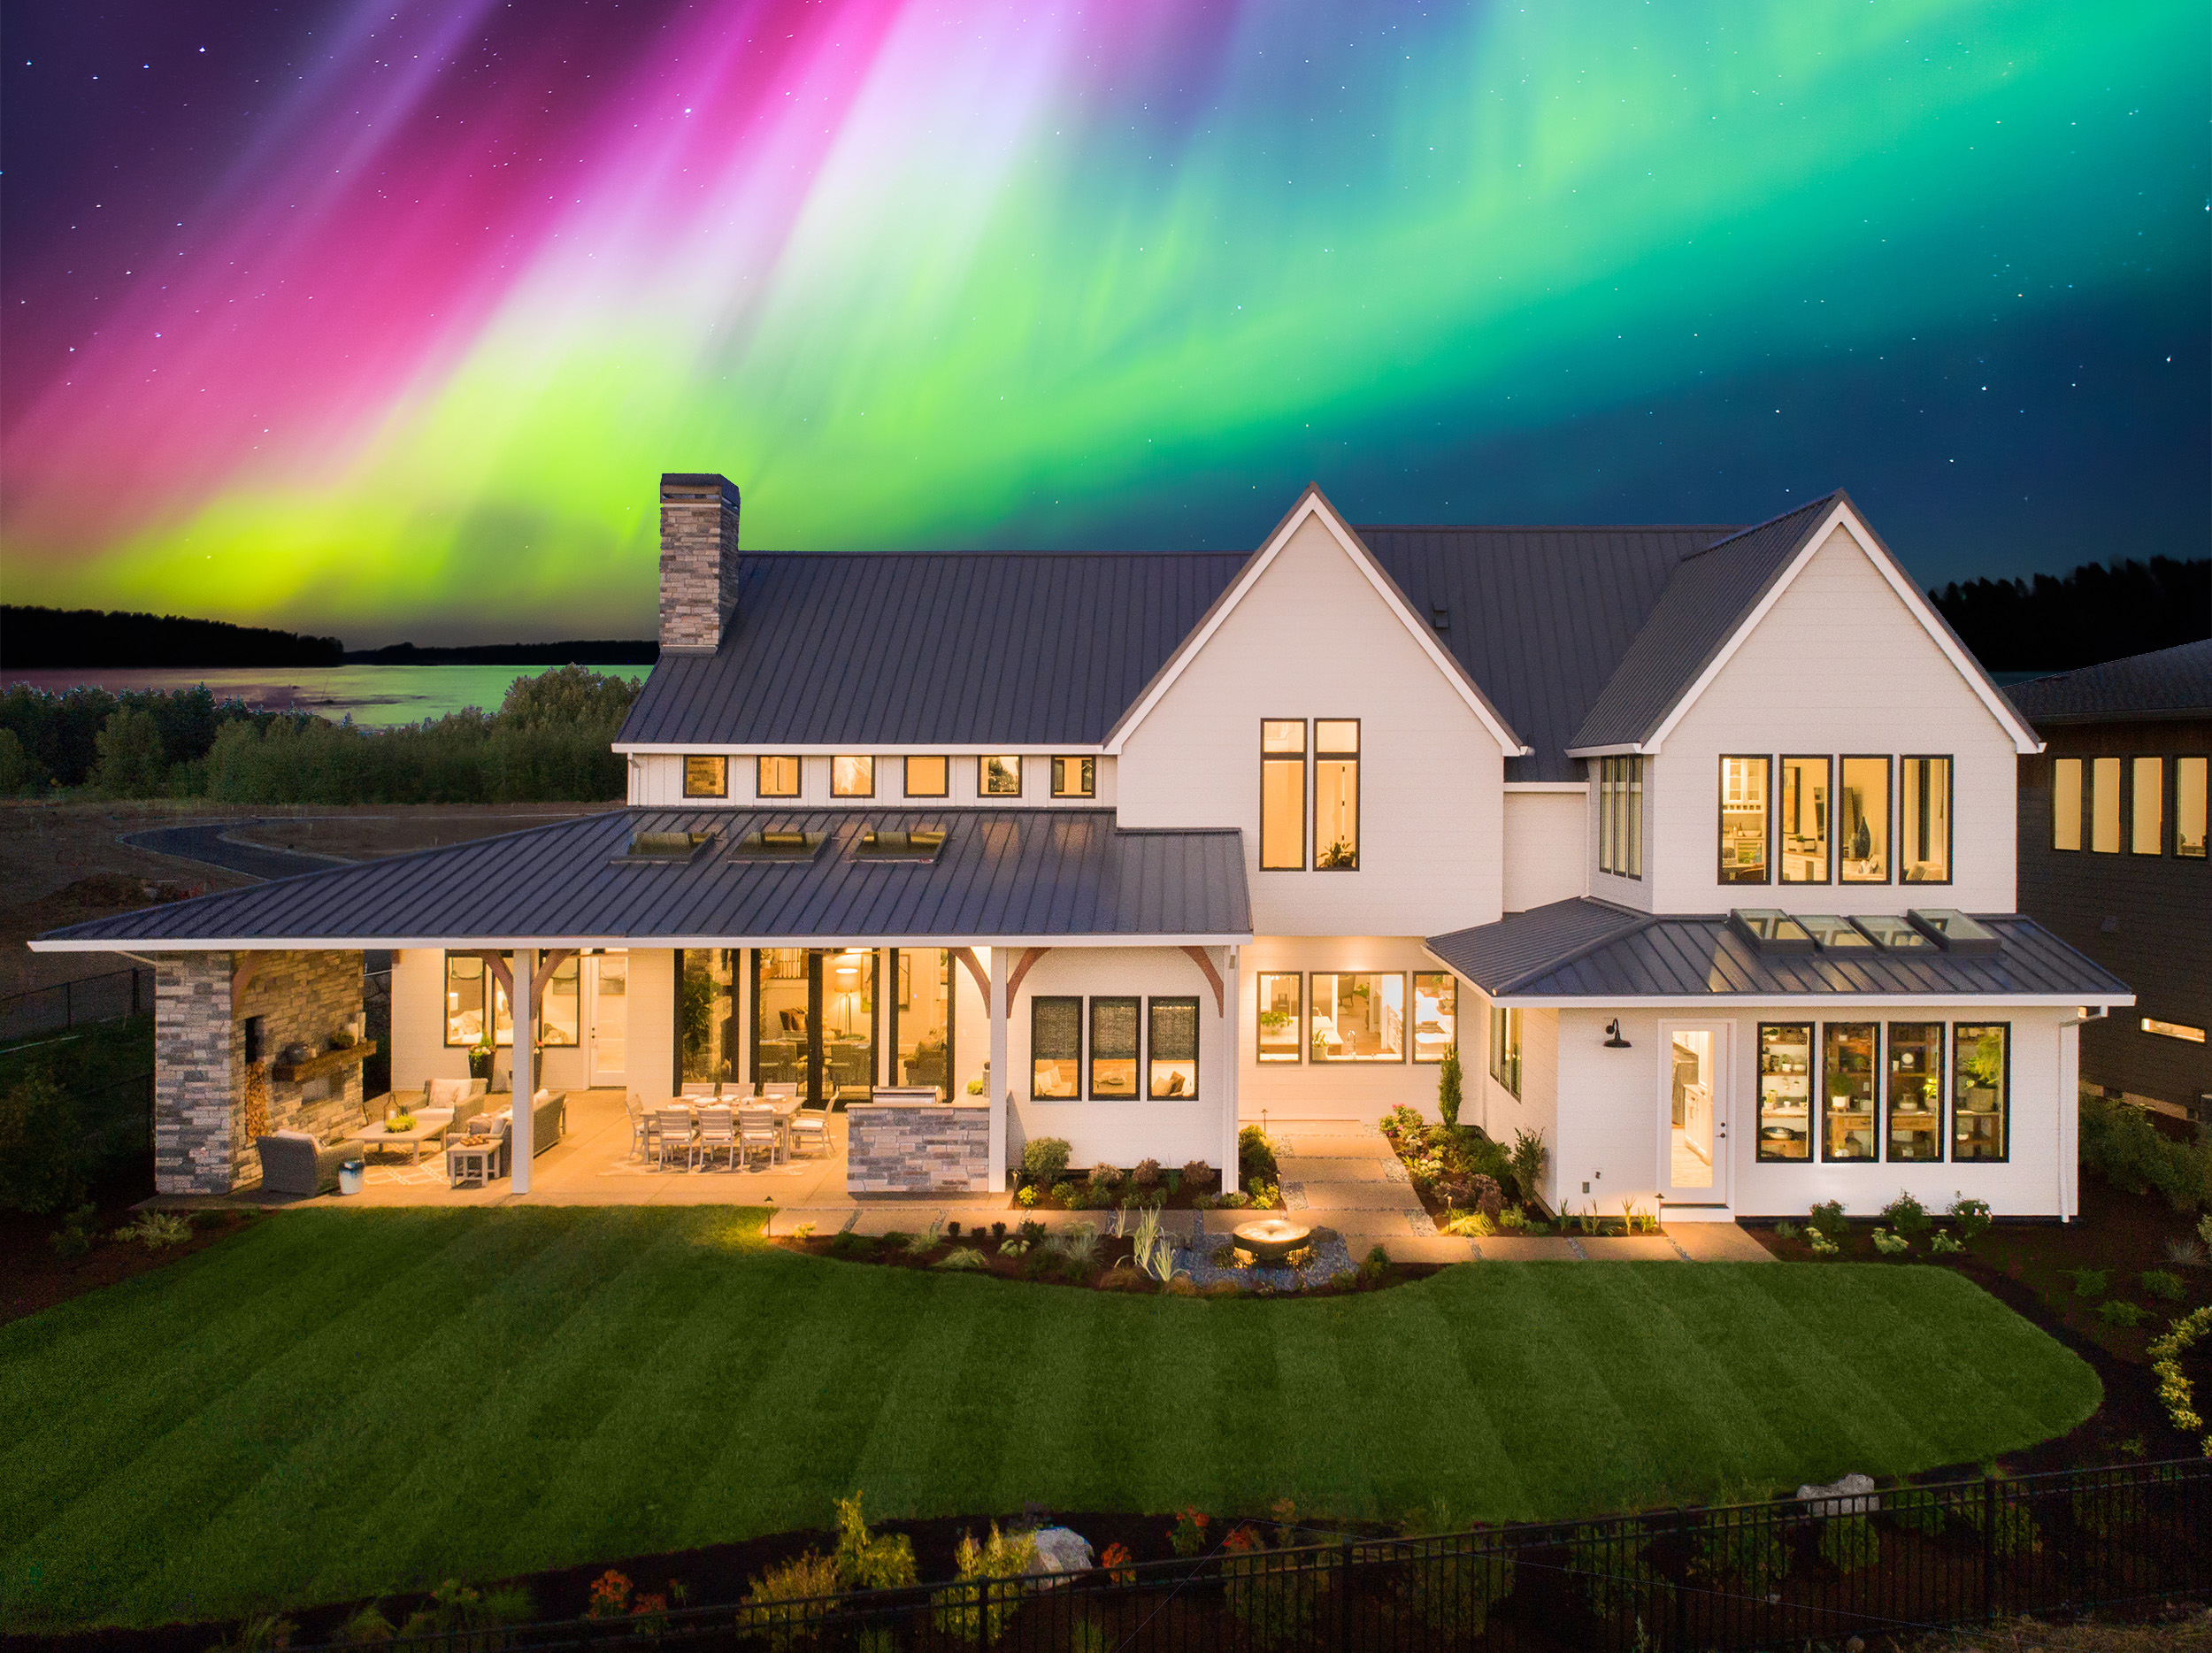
[1004,947,1230,1171]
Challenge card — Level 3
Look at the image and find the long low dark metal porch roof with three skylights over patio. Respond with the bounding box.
[40,808,1252,950]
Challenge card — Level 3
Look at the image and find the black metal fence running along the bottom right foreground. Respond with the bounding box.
[289,1458,2212,1653]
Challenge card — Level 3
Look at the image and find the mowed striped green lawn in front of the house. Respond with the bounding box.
[0,1208,2100,1628]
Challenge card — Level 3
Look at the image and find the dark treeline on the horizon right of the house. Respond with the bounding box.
[1929,557,2212,671]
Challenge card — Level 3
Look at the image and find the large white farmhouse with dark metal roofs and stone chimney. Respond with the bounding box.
[34,476,2132,1219]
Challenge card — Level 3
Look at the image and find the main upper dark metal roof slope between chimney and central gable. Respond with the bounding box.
[615,551,1248,750]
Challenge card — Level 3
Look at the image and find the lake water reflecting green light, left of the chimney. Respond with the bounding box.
[0,666,653,728]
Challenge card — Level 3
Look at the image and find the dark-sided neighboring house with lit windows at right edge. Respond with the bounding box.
[2013,640,2212,1119]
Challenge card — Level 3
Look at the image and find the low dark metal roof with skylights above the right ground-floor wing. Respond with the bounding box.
[1429,898,2132,1003]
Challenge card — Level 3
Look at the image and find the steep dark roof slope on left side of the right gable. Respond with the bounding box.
[1566,491,1843,748]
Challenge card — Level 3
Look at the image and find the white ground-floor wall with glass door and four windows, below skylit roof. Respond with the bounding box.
[1548,1003,2078,1217]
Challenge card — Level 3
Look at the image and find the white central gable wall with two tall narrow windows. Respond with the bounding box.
[1119,520,1504,936]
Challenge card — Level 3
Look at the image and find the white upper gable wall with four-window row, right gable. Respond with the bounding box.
[1646,529,2020,911]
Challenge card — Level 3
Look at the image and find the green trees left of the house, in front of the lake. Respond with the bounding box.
[0,666,637,803]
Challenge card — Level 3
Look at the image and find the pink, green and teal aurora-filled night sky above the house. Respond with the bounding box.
[0,0,2212,646]
